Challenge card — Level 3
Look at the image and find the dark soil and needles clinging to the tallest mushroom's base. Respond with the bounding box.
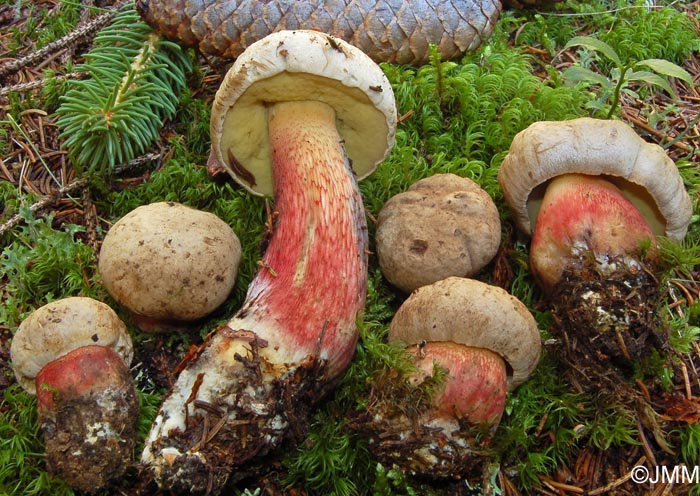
[146,326,328,494]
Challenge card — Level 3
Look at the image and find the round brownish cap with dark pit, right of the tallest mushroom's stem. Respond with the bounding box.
[376,174,501,293]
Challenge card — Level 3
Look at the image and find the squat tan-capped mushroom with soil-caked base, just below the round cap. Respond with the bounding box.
[364,277,541,478]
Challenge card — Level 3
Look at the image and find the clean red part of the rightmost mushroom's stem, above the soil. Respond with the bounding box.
[530,174,654,292]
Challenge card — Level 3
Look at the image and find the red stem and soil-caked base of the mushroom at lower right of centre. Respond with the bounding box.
[351,342,507,479]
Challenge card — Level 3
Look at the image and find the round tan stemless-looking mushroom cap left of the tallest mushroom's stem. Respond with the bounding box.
[99,202,241,321]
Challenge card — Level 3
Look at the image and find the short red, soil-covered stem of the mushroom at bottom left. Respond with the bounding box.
[36,345,139,494]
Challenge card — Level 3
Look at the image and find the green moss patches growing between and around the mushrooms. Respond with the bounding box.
[0,0,700,496]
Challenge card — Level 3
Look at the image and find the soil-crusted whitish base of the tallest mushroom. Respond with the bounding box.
[147,334,324,494]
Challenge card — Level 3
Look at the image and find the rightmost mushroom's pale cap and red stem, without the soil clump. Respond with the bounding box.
[498,118,692,292]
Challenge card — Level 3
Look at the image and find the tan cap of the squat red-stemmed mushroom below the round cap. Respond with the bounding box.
[389,277,541,390]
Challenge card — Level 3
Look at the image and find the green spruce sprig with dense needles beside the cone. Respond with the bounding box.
[57,4,192,176]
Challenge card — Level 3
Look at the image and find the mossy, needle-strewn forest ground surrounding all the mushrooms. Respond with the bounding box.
[0,0,700,496]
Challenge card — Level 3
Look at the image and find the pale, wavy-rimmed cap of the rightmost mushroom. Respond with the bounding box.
[498,117,693,239]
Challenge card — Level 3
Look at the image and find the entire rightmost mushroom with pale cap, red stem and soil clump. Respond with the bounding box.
[498,118,692,366]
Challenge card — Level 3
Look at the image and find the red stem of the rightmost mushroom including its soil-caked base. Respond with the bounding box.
[530,174,668,380]
